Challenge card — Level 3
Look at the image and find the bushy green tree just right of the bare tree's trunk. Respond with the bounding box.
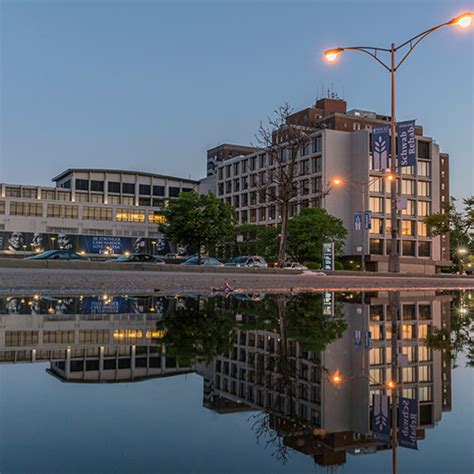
[287,208,347,262]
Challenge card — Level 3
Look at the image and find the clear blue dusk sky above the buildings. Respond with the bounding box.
[0,0,474,197]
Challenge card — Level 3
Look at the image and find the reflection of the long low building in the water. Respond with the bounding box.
[0,297,190,383]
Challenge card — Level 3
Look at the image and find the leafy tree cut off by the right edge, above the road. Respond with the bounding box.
[425,196,474,269]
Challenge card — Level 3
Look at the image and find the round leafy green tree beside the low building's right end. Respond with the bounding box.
[159,191,234,260]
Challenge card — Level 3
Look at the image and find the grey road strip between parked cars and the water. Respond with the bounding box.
[0,268,474,296]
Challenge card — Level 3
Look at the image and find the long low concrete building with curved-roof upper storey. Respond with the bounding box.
[0,169,199,254]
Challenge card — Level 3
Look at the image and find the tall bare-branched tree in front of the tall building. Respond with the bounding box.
[256,103,327,267]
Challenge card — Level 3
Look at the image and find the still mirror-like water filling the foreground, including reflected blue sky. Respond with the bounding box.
[0,292,474,474]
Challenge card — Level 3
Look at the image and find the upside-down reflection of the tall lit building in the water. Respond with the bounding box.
[198,292,452,466]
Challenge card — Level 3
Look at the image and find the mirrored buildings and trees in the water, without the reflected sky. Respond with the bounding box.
[0,292,473,466]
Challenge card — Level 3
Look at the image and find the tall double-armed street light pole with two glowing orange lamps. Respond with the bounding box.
[324,12,474,272]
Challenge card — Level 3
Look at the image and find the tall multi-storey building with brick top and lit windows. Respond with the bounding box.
[216,99,450,273]
